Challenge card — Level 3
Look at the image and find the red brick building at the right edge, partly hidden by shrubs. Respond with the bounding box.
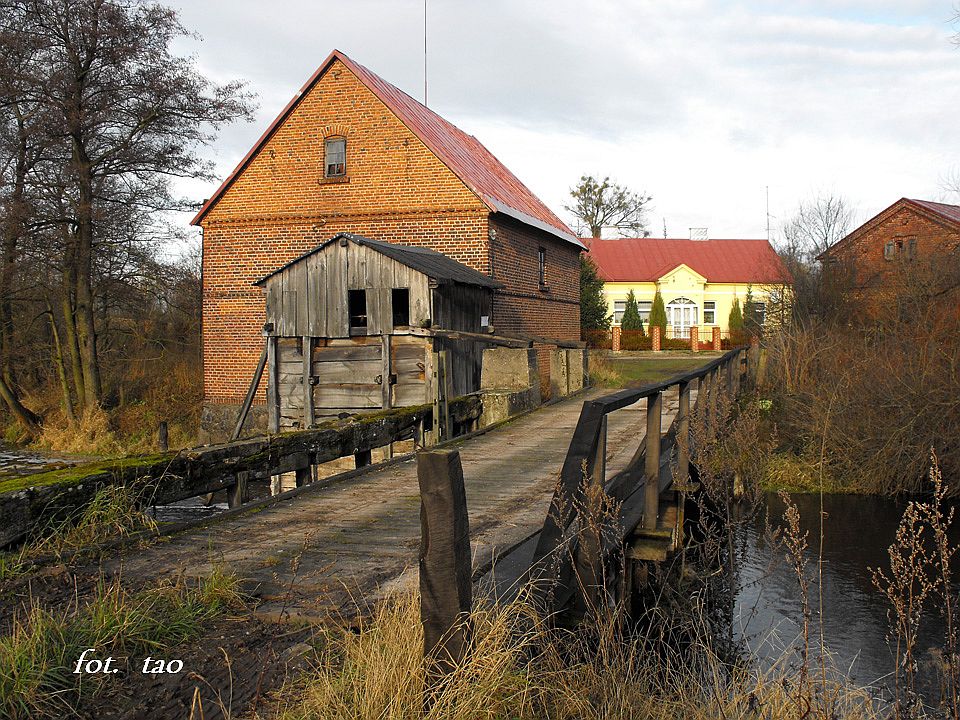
[818,198,960,316]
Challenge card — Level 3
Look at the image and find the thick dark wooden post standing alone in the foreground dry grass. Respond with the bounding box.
[417,450,473,689]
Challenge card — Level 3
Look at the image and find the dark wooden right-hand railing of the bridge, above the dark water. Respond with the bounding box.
[527,345,758,611]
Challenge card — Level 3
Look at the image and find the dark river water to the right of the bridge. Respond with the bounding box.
[734,495,960,702]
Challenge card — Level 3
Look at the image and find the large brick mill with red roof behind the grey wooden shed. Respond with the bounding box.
[193,50,583,438]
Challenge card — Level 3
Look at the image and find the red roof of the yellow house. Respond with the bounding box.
[585,238,792,284]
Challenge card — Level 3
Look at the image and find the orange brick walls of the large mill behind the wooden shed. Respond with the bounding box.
[201,61,579,430]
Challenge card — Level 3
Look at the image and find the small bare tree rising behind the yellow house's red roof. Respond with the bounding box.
[564,175,653,238]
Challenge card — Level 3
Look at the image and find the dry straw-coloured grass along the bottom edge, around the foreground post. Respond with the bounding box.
[261,595,879,720]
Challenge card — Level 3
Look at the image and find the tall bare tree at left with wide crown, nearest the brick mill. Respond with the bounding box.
[0,0,252,408]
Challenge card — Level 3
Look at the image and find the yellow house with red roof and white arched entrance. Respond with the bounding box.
[585,238,792,338]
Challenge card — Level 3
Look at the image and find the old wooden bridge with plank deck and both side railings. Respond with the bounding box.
[4,348,749,618]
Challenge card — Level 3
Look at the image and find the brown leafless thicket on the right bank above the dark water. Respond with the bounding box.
[763,314,960,495]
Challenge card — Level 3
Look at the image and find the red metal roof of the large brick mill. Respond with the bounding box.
[192,50,581,245]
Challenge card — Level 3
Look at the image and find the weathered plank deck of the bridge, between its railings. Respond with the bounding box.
[104,389,677,618]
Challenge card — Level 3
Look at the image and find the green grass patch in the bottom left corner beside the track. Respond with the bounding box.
[0,570,243,720]
